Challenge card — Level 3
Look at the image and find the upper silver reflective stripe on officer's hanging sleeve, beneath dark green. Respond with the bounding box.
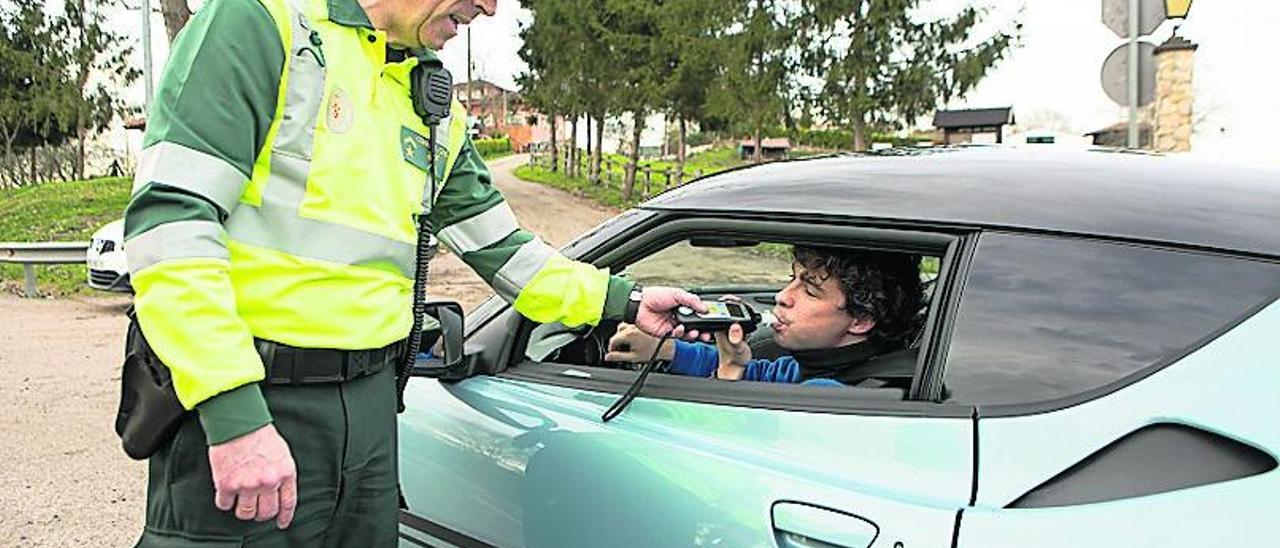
[133,141,248,211]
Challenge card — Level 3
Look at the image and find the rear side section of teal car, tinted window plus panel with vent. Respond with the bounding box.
[945,230,1280,547]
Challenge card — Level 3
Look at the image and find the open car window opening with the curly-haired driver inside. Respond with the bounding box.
[525,237,938,389]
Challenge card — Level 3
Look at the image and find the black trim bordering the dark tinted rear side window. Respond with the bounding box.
[952,228,1280,419]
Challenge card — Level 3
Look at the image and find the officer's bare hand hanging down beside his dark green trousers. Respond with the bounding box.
[209,424,298,529]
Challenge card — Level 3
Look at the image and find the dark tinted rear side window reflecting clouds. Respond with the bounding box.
[945,233,1280,405]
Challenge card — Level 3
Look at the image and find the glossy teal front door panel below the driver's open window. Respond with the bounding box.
[401,378,973,547]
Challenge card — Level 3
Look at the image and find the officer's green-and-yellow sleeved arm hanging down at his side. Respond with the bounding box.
[124,0,284,444]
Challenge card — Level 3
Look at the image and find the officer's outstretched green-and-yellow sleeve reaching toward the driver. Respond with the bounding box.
[430,138,632,325]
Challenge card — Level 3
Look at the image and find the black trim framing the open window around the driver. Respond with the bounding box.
[495,213,974,419]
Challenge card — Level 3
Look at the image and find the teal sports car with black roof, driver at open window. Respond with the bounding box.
[399,147,1280,548]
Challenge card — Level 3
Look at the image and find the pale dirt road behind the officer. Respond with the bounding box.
[0,156,613,548]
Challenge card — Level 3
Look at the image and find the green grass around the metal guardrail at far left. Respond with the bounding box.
[0,177,131,296]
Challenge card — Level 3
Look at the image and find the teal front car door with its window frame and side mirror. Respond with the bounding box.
[401,218,974,548]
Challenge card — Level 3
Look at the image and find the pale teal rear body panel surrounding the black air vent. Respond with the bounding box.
[960,301,1280,547]
